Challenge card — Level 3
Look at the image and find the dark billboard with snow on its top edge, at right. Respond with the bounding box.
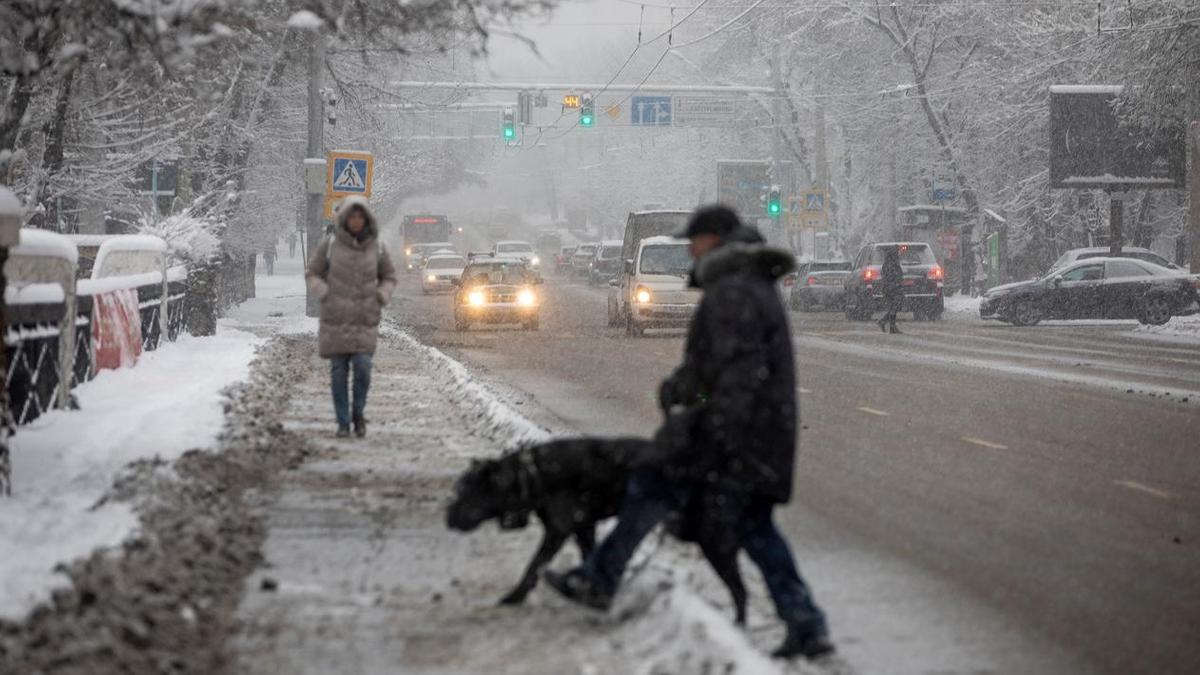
[1050,85,1186,190]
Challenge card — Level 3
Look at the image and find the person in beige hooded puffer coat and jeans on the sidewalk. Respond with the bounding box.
[305,197,396,437]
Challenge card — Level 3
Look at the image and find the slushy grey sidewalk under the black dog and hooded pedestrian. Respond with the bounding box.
[229,330,829,675]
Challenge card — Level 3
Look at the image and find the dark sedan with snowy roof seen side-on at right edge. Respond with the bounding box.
[979,258,1200,325]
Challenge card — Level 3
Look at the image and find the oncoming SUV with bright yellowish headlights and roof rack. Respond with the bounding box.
[454,255,541,330]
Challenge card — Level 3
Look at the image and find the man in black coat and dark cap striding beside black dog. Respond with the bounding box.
[546,205,834,658]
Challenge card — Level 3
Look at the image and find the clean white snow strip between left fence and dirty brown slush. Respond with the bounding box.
[0,328,259,619]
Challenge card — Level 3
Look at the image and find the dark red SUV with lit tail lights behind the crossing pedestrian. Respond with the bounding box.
[842,241,946,321]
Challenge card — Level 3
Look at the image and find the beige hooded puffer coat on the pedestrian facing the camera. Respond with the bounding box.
[305,197,396,358]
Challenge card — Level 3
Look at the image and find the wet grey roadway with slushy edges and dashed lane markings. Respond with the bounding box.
[400,269,1200,673]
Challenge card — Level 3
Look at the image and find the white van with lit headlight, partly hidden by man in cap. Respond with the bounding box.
[608,237,700,336]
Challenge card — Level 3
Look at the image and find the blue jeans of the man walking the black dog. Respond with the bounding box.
[581,468,829,637]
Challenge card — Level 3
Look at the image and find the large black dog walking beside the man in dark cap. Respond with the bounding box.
[446,438,746,625]
